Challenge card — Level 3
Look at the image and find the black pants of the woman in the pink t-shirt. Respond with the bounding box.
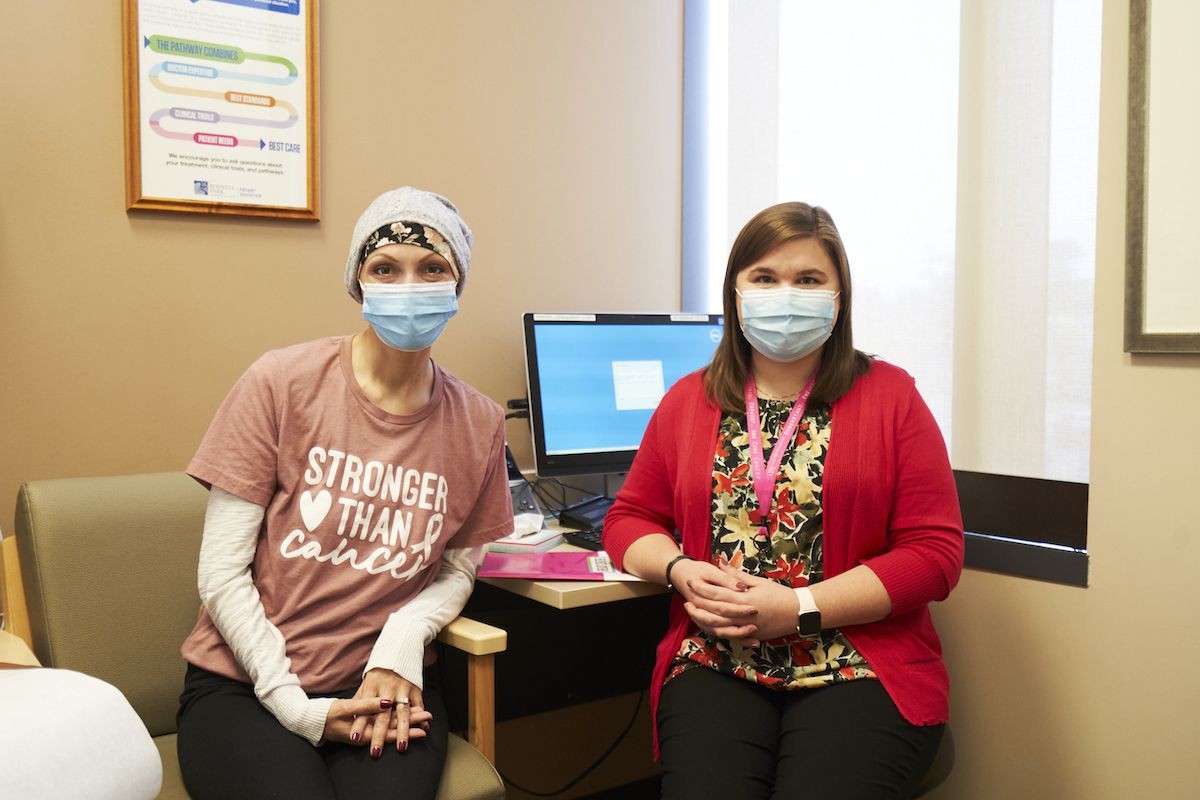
[179,664,446,800]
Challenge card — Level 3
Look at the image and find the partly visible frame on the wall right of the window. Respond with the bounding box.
[1124,0,1200,353]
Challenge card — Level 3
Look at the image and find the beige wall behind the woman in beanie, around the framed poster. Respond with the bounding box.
[0,0,683,529]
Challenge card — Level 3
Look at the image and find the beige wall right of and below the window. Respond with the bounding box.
[935,0,1200,800]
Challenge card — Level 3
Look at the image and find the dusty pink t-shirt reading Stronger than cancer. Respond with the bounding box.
[182,337,512,693]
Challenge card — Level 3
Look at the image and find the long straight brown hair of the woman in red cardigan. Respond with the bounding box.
[704,203,871,413]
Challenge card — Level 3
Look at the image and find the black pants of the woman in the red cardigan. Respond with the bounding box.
[658,668,944,800]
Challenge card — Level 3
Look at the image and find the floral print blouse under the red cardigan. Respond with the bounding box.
[666,398,875,690]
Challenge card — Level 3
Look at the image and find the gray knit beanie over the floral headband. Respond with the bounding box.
[346,186,474,302]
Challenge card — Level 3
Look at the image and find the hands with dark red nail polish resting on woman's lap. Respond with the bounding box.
[323,668,433,758]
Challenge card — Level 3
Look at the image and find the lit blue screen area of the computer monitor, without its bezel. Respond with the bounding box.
[534,324,721,456]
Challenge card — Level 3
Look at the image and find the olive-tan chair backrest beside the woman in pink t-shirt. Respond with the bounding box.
[17,473,208,735]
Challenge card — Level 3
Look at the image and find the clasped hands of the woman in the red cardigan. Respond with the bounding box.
[672,560,800,648]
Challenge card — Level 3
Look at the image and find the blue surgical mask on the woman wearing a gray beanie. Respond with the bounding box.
[361,281,458,350]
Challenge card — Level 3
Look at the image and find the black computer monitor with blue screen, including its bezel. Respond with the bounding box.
[523,313,722,477]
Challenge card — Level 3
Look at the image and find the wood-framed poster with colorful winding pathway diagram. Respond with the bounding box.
[122,0,319,219]
